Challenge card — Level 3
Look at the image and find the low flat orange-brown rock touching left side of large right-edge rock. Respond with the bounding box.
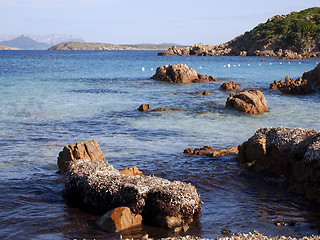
[183,146,238,157]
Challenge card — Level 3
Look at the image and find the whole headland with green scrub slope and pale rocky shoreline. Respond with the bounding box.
[158,7,320,59]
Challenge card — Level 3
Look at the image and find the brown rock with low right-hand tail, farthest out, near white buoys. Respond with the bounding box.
[151,64,217,83]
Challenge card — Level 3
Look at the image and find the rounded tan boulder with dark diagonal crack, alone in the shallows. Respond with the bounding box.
[226,90,268,114]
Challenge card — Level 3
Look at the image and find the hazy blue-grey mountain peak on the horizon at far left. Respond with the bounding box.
[0,35,50,50]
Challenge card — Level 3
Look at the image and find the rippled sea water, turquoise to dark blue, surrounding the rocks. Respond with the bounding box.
[0,51,320,239]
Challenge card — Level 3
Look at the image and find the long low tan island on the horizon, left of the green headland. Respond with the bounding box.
[48,42,186,50]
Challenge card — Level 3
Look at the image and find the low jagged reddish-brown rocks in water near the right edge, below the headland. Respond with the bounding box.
[270,76,313,95]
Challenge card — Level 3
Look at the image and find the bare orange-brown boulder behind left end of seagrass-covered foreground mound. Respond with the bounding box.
[58,140,106,172]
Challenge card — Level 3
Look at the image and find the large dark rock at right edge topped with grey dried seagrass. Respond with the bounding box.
[239,127,320,203]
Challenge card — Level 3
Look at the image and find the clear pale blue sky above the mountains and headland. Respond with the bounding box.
[0,0,320,45]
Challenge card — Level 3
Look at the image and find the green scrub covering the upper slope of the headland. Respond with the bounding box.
[247,7,320,48]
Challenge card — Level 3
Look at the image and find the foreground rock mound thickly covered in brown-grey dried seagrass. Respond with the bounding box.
[65,159,202,227]
